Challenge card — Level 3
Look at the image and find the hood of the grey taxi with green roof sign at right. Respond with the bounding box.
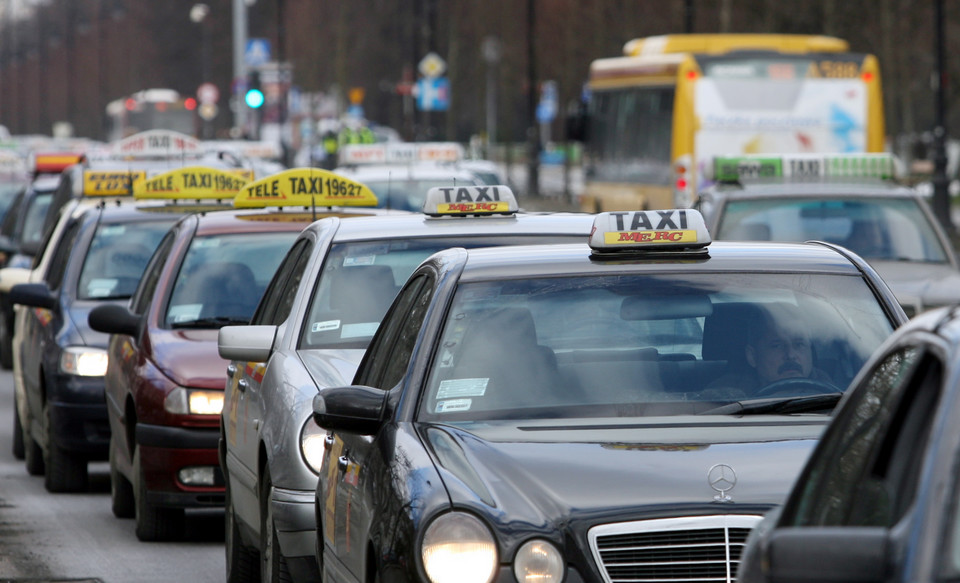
[870,260,960,315]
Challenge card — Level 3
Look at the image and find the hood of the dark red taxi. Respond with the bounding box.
[150,329,227,390]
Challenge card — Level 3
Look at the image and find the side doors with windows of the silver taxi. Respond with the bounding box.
[223,238,313,525]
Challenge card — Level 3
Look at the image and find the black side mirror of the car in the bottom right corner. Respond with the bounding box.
[766,527,890,583]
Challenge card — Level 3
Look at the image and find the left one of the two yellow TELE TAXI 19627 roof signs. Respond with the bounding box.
[133,166,250,200]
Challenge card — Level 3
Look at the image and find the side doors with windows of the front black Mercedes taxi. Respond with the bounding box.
[325,274,435,581]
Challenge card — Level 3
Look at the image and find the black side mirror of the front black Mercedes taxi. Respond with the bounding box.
[313,385,387,435]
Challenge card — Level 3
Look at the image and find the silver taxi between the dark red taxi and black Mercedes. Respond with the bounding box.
[219,186,592,582]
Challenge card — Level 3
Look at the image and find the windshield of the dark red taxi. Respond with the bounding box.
[161,231,298,328]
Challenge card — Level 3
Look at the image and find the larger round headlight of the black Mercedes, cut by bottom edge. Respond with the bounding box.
[420,512,497,583]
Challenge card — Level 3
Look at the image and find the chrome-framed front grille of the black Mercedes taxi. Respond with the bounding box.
[589,514,761,583]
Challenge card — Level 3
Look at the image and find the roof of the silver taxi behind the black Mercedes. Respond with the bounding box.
[309,213,594,242]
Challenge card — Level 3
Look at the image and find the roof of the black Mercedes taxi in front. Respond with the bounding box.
[452,241,861,281]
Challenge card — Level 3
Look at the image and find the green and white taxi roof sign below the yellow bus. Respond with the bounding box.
[713,153,897,182]
